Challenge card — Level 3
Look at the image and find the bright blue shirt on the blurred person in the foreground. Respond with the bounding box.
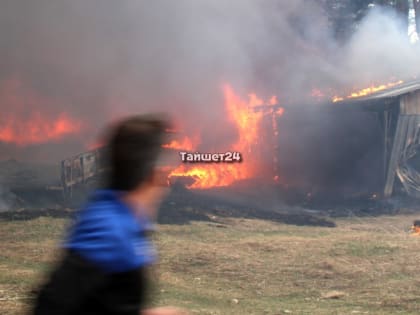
[64,190,156,273]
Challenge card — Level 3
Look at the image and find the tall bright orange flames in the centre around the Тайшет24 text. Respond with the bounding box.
[169,85,282,189]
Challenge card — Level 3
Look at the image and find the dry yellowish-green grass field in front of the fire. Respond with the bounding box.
[0,215,420,315]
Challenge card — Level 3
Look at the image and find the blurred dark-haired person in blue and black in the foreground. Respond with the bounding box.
[33,116,186,315]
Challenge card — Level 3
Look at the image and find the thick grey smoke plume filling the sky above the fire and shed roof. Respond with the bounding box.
[0,0,420,160]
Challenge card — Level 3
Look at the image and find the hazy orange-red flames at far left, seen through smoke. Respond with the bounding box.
[0,113,82,146]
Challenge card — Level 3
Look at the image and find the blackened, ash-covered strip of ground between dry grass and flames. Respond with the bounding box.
[0,160,420,227]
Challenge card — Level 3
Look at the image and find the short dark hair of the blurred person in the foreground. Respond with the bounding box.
[107,115,170,191]
